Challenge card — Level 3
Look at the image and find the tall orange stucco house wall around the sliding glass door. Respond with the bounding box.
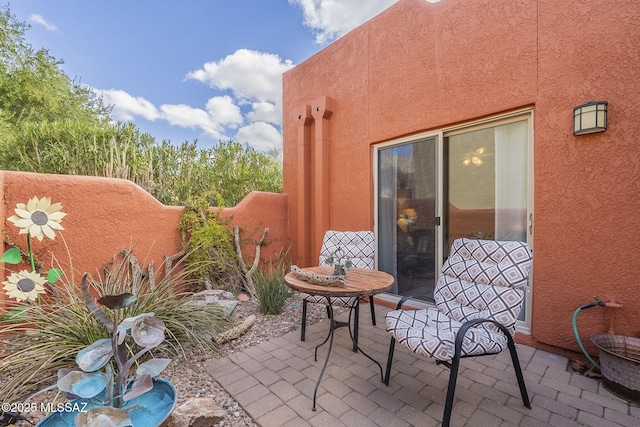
[283,0,640,356]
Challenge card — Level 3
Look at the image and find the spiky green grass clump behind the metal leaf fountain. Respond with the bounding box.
[0,252,230,402]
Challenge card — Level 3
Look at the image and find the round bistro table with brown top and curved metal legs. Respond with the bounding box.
[284,267,394,411]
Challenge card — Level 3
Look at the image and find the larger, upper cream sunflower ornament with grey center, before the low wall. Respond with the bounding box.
[7,197,66,241]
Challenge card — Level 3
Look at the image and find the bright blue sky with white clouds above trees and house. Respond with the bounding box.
[9,0,408,151]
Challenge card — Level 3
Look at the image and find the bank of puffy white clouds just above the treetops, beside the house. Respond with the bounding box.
[94,49,293,151]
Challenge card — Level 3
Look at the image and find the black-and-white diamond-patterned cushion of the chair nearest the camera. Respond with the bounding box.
[386,239,532,360]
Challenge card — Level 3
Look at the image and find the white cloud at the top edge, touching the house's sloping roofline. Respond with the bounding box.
[289,0,397,44]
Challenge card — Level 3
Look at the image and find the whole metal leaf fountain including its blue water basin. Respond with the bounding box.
[37,273,177,427]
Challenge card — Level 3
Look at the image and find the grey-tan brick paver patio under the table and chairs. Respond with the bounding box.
[207,306,640,427]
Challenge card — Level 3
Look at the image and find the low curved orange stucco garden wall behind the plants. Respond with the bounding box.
[0,171,289,308]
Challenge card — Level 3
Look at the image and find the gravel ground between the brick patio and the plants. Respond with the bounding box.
[0,293,336,427]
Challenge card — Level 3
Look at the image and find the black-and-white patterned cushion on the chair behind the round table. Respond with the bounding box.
[303,230,376,307]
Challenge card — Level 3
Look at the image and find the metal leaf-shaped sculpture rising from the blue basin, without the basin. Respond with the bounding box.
[57,273,171,427]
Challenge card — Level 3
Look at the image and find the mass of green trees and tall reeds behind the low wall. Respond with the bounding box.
[0,6,282,206]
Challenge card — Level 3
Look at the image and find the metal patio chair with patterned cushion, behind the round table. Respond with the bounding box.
[300,230,376,351]
